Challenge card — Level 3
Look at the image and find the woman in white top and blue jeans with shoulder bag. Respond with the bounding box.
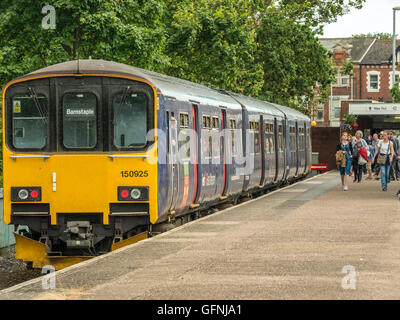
[372,131,394,191]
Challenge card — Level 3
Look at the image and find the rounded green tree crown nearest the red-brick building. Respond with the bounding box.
[257,6,335,113]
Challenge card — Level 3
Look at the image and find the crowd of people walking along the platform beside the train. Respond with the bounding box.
[336,130,400,191]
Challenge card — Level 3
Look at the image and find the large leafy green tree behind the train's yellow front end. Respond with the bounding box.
[0,0,168,83]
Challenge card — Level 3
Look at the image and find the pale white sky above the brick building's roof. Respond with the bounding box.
[323,0,400,38]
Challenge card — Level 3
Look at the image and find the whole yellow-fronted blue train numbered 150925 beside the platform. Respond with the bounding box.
[3,59,311,269]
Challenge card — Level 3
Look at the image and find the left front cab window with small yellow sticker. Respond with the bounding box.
[12,95,48,149]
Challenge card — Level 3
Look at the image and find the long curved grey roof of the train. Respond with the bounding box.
[14,59,309,120]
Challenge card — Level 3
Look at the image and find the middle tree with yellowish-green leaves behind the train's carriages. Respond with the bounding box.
[162,0,263,96]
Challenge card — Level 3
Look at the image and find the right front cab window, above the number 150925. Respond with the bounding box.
[114,93,147,148]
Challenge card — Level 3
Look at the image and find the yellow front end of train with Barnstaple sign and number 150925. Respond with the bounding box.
[3,60,158,269]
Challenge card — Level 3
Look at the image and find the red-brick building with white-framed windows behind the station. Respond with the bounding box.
[314,37,400,130]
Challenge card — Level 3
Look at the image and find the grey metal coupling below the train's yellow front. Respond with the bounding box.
[64,221,94,248]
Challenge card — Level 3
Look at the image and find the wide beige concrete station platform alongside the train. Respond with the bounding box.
[0,172,400,299]
